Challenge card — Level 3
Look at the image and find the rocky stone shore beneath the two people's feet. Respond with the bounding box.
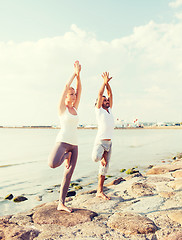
[0,154,182,240]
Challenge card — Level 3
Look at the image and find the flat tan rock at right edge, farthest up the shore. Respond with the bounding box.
[146,164,182,175]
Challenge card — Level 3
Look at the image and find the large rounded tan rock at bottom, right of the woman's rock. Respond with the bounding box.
[107,212,157,235]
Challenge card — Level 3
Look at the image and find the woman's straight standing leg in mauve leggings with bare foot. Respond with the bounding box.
[57,143,78,212]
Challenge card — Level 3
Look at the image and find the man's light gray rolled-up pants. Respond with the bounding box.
[92,140,112,176]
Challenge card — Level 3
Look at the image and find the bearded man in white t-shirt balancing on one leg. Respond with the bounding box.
[92,72,114,200]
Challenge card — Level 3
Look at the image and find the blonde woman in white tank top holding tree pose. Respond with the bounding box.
[49,61,81,212]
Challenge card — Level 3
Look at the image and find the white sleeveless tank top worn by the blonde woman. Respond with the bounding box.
[56,107,78,145]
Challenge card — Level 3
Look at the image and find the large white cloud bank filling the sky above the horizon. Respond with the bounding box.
[0,21,182,125]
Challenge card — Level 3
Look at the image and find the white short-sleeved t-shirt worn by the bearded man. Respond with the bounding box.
[95,107,114,141]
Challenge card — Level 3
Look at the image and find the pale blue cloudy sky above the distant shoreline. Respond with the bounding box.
[0,0,182,126]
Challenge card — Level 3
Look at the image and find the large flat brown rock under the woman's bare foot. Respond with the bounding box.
[32,202,97,227]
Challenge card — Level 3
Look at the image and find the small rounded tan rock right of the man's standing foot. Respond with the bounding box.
[131,183,155,196]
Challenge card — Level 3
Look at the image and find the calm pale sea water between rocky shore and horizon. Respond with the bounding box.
[0,128,182,215]
